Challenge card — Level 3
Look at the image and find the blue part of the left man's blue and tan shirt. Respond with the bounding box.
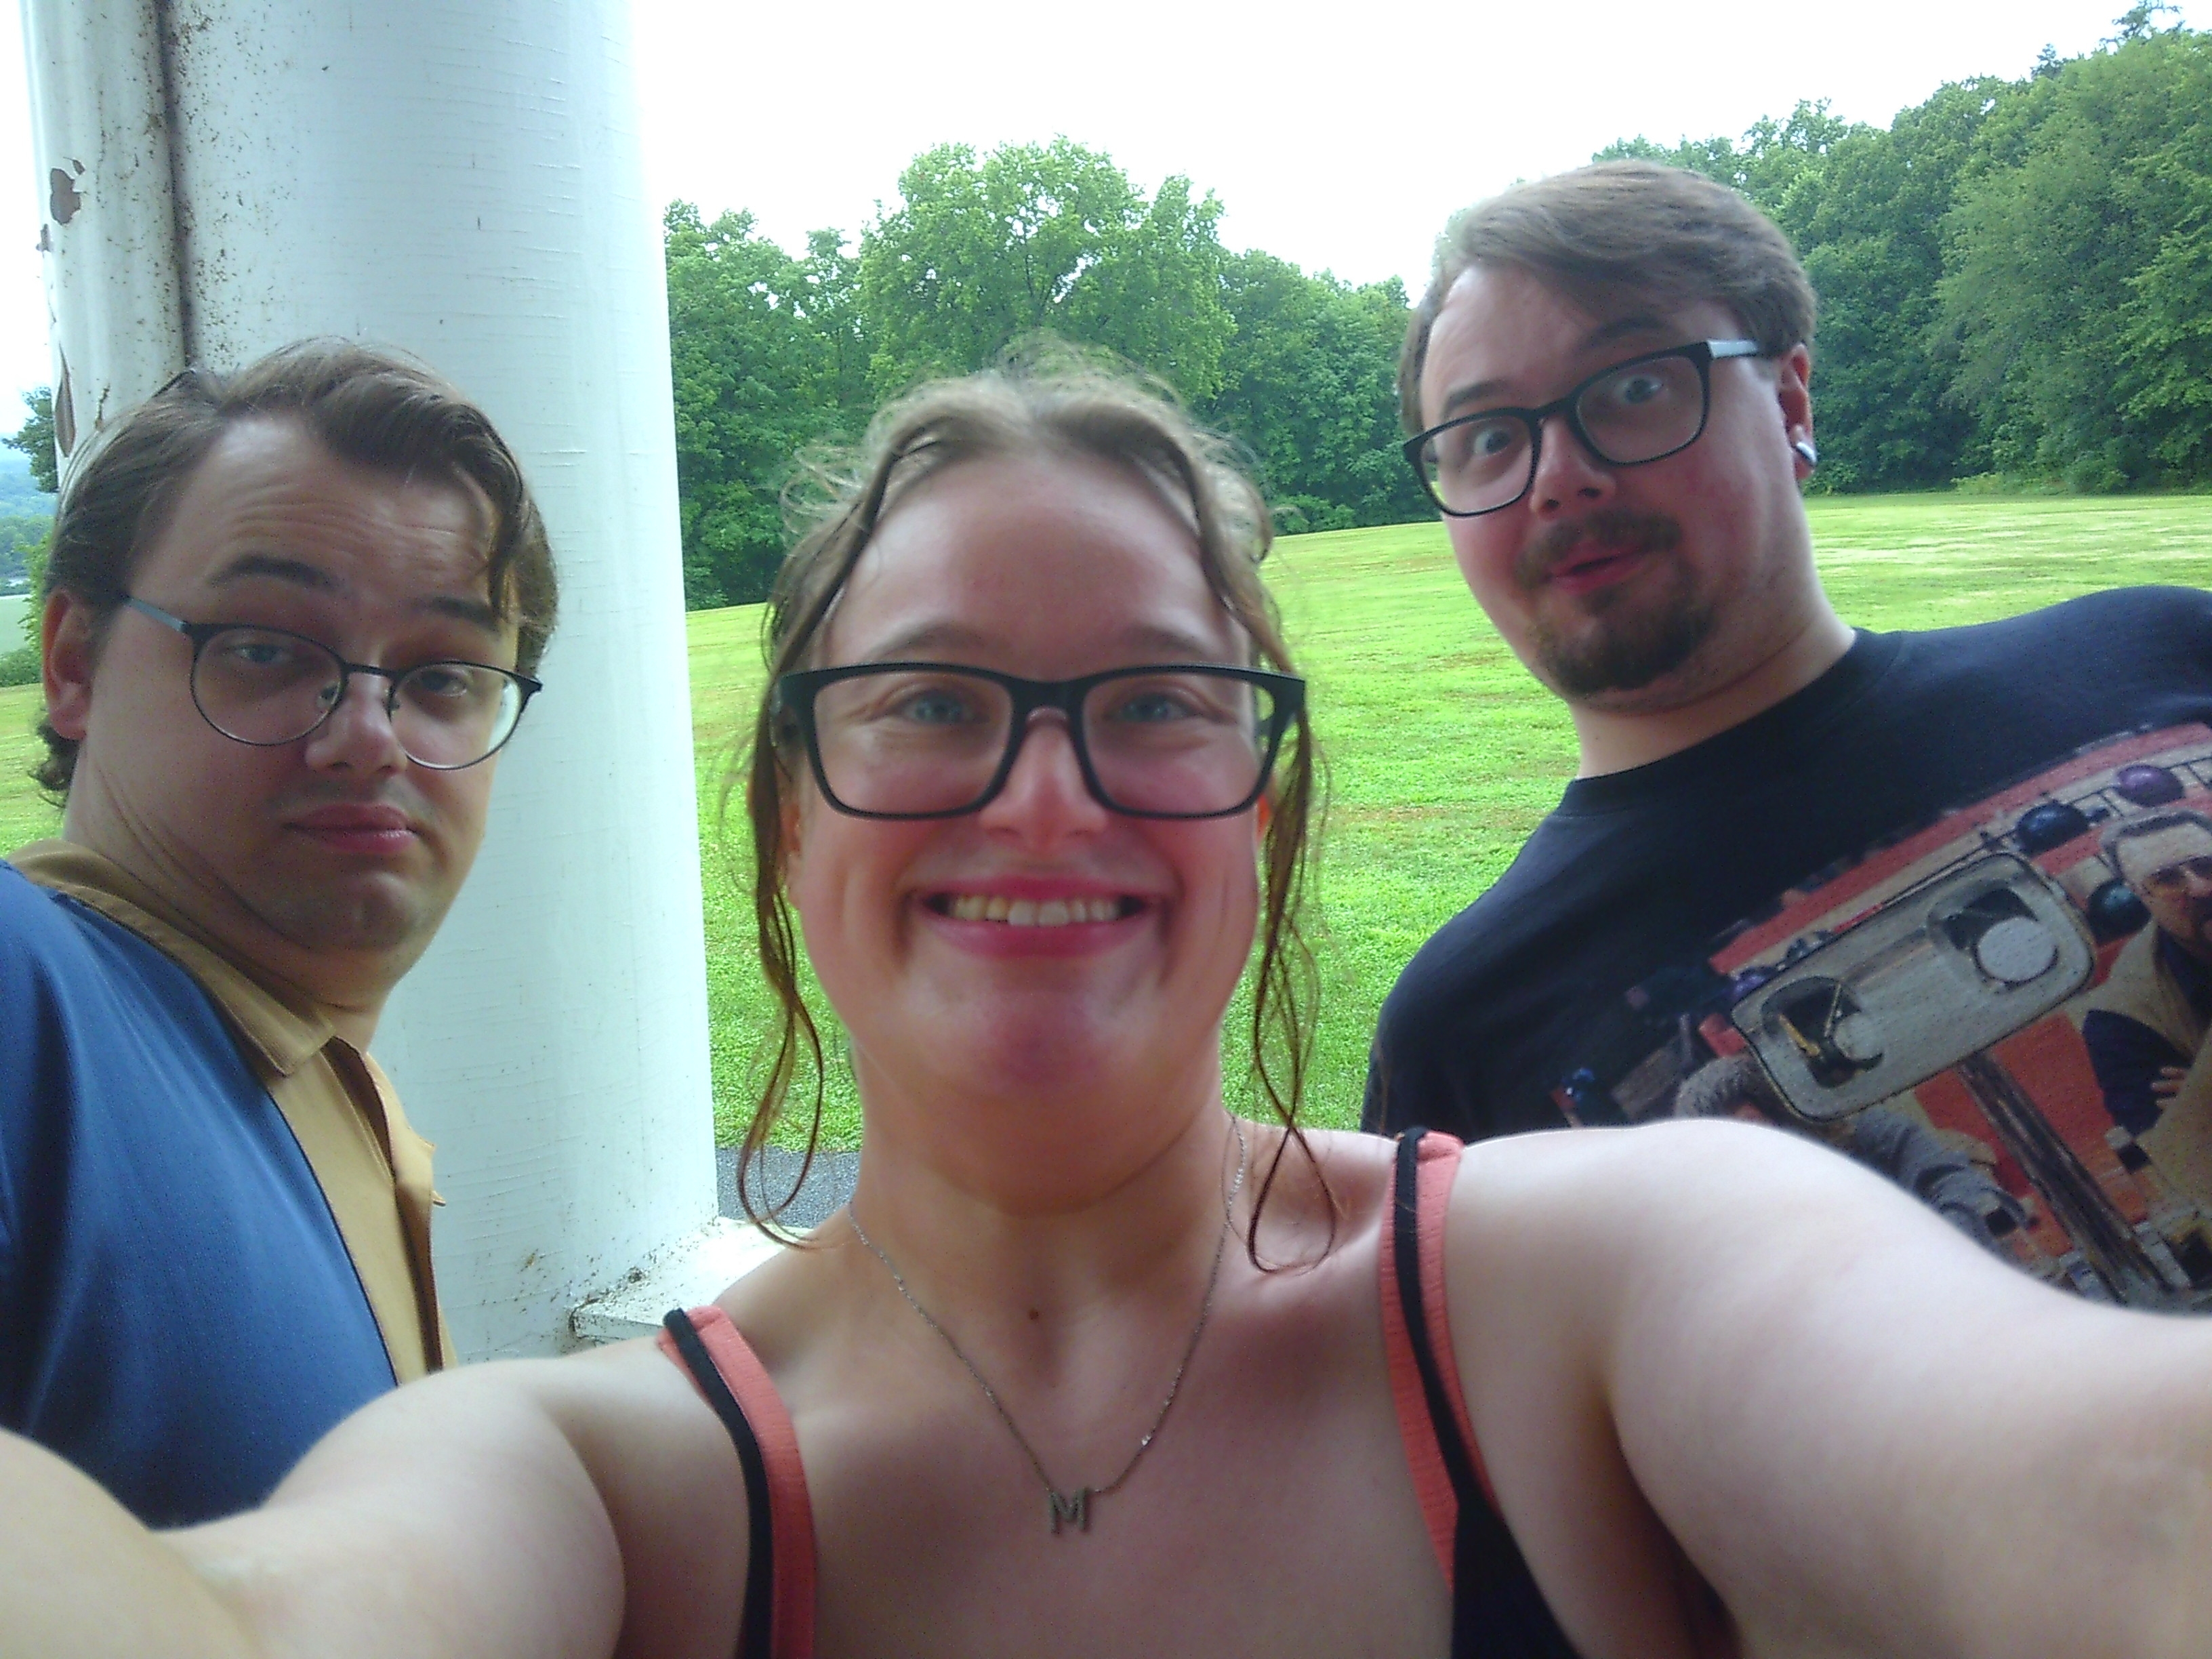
[0,863,394,1526]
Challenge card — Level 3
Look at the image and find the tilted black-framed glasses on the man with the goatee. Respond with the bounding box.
[1405,341,1767,518]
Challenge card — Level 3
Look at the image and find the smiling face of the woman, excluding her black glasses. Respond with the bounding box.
[785,455,1258,1132]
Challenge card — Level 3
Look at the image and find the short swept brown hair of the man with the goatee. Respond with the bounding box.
[1398,161,1814,431]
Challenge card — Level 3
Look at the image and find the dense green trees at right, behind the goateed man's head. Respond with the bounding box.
[1599,5,2212,491]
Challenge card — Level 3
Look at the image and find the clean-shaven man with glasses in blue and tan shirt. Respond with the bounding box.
[0,341,555,1524]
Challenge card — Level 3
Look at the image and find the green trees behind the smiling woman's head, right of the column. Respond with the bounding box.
[663,137,1420,606]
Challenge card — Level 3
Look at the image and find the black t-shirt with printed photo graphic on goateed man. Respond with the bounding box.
[1367,588,2212,1307]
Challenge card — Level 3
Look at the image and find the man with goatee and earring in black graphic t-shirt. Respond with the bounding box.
[1367,161,2212,1305]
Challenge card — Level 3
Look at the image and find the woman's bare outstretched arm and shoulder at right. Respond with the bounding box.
[1447,1124,2212,1659]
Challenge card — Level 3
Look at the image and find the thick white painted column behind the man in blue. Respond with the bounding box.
[26,0,717,1358]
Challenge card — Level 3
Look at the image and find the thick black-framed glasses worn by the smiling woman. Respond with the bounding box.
[777,661,1305,819]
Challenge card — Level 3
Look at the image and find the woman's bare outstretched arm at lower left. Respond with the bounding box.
[0,1343,745,1659]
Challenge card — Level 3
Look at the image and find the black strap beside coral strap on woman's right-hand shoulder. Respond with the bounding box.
[1391,1128,1575,1659]
